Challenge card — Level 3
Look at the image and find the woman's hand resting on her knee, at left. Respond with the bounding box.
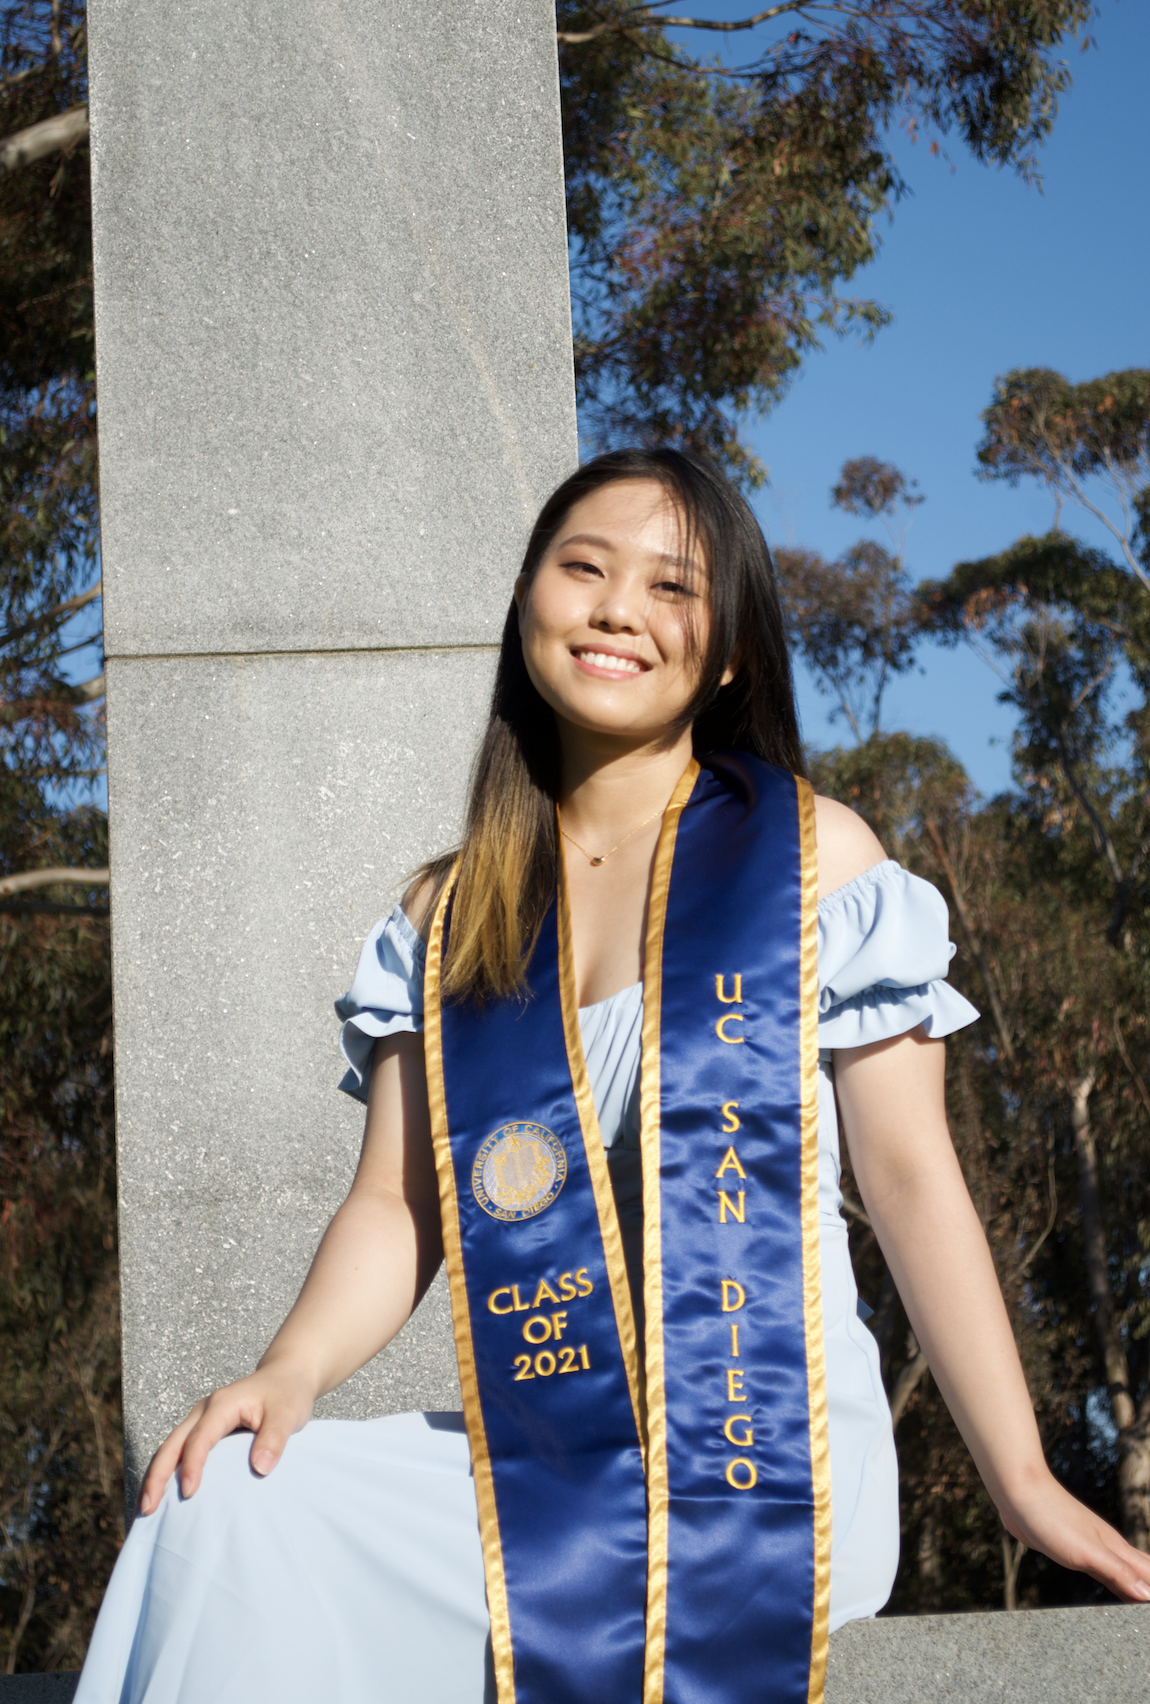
[140,1365,315,1515]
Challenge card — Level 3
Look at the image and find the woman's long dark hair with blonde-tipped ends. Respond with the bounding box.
[424,450,806,1000]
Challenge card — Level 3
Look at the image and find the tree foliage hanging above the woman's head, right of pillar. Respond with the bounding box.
[557,0,1094,484]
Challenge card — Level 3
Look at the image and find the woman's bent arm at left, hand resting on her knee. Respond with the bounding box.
[140,1033,443,1515]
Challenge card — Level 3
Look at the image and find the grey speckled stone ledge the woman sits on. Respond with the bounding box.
[0,1605,1150,1704]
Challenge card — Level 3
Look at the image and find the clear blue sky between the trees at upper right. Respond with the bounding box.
[729,0,1150,794]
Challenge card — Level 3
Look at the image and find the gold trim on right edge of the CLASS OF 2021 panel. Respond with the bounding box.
[555,835,647,1467]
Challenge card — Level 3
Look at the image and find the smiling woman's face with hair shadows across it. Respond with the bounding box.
[515,479,729,741]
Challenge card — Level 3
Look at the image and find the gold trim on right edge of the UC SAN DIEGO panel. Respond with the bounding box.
[796,775,831,1704]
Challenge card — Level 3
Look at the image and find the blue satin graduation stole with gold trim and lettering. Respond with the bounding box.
[424,751,830,1704]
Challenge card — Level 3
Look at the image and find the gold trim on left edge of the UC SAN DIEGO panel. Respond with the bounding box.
[639,758,699,1704]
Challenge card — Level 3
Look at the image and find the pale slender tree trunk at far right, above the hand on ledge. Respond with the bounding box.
[1070,1070,1150,1551]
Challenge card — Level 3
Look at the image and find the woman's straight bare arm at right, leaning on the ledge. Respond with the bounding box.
[835,1029,1150,1602]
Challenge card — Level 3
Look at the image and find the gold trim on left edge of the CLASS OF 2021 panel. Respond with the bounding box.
[423,864,515,1704]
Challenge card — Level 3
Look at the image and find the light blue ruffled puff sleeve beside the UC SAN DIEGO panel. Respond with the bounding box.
[818,859,978,1051]
